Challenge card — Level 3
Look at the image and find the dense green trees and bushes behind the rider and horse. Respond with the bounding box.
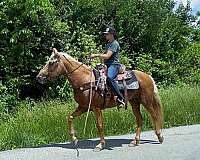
[0,0,200,102]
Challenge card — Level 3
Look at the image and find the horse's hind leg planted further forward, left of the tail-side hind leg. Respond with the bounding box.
[129,99,143,147]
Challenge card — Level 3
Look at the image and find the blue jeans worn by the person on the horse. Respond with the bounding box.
[107,64,124,100]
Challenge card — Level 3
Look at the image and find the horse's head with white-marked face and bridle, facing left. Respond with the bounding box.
[36,48,63,84]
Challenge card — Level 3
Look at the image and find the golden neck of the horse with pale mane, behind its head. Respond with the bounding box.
[61,55,94,88]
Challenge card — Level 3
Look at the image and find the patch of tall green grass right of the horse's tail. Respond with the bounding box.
[160,86,200,127]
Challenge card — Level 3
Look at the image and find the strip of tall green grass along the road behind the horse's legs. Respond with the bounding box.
[0,86,200,150]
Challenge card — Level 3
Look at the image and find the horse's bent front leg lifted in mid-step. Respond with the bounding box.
[67,106,87,145]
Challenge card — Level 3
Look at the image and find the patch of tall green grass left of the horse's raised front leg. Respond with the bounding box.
[0,101,70,150]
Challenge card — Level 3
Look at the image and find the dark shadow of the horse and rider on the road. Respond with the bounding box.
[42,139,160,150]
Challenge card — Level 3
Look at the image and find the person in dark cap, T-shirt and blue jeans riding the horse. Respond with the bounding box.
[91,27,125,105]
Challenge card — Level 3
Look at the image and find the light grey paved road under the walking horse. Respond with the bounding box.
[0,125,200,160]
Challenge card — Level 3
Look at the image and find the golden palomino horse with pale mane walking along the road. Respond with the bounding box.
[37,48,164,151]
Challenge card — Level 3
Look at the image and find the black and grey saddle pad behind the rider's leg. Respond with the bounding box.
[116,71,139,90]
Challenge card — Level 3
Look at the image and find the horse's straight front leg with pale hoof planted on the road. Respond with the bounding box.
[93,108,105,152]
